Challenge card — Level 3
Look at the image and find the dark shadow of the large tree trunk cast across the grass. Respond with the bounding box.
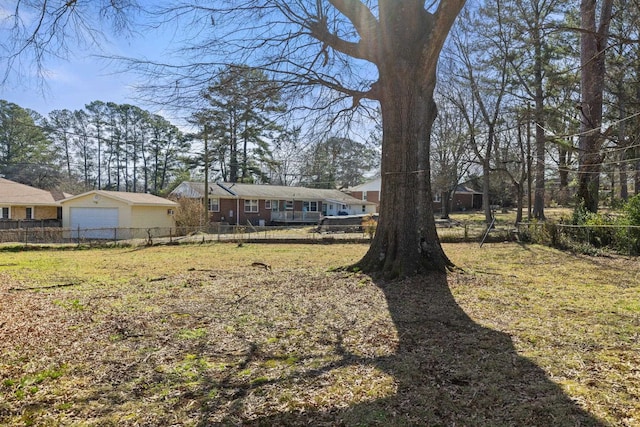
[239,274,605,426]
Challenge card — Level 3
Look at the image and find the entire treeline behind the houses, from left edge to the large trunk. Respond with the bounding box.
[0,94,379,195]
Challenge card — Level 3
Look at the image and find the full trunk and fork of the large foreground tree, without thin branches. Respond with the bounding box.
[348,0,464,278]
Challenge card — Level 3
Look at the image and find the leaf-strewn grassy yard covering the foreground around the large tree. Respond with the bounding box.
[0,243,640,426]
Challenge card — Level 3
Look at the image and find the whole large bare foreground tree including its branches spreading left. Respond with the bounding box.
[1,0,465,277]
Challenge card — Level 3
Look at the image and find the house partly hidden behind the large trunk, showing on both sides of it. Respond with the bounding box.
[346,178,482,212]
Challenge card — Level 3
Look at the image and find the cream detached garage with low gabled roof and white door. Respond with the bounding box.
[60,190,178,239]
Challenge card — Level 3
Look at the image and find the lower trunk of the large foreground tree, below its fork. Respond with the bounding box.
[358,67,453,277]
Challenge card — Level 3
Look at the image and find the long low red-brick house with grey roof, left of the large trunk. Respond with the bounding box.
[169,181,376,225]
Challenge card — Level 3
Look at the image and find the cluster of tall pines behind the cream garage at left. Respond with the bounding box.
[0,101,190,194]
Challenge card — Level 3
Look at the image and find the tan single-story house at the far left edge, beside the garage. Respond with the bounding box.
[0,178,69,228]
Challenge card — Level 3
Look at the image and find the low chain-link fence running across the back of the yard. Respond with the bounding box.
[0,223,640,255]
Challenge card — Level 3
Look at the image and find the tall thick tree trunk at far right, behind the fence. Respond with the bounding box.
[578,0,613,212]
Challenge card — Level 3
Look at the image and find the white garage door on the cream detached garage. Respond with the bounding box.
[69,208,118,239]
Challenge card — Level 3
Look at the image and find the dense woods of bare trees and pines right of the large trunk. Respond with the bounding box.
[431,0,640,219]
